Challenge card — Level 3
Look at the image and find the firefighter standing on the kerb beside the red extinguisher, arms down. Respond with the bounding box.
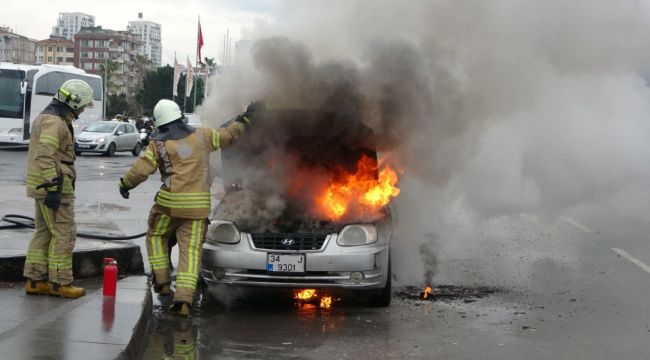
[23,79,93,299]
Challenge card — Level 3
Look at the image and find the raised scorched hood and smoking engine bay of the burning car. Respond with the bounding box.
[214,110,384,232]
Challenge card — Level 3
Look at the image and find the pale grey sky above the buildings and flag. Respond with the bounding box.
[0,0,277,64]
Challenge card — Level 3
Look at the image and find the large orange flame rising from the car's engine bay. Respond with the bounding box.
[316,155,400,221]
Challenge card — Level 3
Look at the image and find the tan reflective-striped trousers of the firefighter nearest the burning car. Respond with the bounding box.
[146,205,207,304]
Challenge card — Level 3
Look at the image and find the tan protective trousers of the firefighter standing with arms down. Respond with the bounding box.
[23,199,77,286]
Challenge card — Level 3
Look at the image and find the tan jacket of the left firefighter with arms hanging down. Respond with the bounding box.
[27,100,76,203]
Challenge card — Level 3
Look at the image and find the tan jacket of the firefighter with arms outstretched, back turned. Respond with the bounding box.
[122,121,245,219]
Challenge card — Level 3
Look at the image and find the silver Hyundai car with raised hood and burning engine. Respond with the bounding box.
[201,110,399,306]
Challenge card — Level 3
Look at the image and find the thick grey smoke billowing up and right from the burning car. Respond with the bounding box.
[200,0,650,284]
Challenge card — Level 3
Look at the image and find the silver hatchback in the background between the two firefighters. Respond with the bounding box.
[74,121,142,156]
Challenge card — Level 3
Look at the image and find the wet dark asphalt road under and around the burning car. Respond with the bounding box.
[0,151,650,359]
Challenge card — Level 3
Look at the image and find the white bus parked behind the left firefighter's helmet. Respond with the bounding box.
[0,63,104,148]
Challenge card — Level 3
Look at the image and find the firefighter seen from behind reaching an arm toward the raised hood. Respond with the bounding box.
[119,99,264,316]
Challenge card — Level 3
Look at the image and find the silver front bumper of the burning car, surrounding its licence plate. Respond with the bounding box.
[201,233,389,290]
